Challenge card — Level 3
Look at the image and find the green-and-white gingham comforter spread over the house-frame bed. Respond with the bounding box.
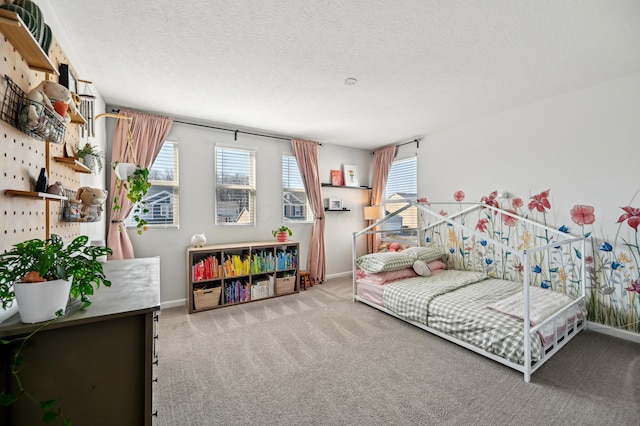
[382,270,543,364]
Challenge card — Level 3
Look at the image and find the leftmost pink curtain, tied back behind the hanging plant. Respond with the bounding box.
[107,109,173,259]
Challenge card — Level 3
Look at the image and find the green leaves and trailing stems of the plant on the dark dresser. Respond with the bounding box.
[0,235,112,426]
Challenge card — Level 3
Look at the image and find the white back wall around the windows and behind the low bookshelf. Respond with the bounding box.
[108,120,372,306]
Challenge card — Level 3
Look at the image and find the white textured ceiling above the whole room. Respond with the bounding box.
[36,0,640,149]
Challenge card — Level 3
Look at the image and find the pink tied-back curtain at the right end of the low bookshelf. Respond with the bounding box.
[291,139,327,283]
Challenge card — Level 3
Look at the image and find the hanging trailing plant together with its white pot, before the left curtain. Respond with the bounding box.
[113,161,151,235]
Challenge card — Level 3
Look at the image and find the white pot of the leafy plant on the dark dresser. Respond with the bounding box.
[13,280,71,324]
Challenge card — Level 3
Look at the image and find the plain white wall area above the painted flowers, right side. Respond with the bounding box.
[418,73,640,238]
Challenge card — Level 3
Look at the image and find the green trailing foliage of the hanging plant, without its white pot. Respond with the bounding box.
[113,161,151,235]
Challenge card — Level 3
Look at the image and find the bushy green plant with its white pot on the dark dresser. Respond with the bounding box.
[0,235,112,323]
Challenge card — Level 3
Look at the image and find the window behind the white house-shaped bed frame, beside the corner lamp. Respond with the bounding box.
[383,156,418,243]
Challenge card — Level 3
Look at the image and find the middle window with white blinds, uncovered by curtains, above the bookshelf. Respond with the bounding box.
[216,147,256,225]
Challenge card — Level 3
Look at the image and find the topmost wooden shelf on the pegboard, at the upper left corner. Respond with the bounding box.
[0,9,60,75]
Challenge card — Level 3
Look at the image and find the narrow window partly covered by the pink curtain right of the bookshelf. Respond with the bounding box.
[282,154,313,222]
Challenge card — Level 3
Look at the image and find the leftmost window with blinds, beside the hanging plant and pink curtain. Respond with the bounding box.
[125,141,180,229]
